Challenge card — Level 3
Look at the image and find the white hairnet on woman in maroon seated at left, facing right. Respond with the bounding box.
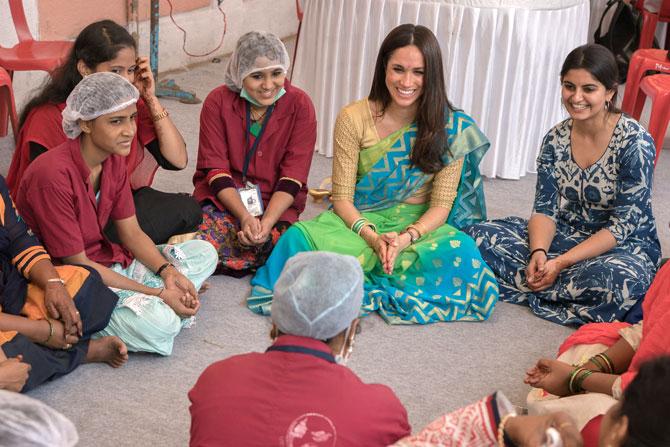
[63,71,140,139]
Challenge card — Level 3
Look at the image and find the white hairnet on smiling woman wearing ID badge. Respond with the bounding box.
[224,31,291,92]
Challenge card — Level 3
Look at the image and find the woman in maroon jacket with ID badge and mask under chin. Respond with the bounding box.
[193,32,316,277]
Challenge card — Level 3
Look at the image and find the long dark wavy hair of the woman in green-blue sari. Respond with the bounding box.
[368,23,454,174]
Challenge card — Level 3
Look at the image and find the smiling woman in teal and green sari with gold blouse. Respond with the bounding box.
[247,24,498,324]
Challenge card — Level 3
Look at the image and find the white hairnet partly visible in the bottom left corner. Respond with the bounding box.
[0,390,79,447]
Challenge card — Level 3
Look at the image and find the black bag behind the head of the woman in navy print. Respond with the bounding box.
[593,0,642,84]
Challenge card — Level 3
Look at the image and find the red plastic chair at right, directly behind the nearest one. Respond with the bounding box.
[621,48,670,117]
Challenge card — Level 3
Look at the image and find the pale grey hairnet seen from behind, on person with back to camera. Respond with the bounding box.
[271,251,363,340]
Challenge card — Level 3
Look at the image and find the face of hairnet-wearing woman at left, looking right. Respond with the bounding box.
[80,104,137,157]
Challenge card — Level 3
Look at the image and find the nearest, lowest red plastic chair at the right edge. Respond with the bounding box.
[634,74,670,164]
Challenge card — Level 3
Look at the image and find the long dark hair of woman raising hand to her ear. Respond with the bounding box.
[19,20,137,127]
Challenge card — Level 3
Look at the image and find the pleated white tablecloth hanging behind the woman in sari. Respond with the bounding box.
[293,0,590,179]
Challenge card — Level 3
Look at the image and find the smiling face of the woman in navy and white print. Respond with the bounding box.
[561,68,614,121]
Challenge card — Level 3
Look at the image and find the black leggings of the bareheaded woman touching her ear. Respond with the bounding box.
[105,186,202,244]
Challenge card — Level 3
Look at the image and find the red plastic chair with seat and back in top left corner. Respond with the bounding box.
[0,0,73,77]
